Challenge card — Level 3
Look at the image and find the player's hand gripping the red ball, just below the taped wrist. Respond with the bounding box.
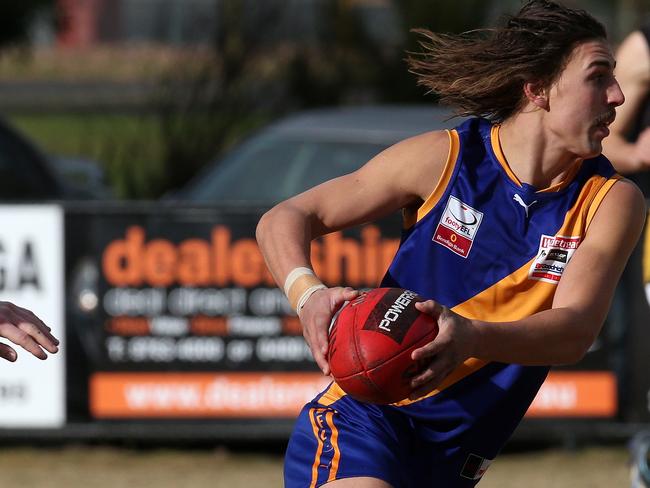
[298,287,359,375]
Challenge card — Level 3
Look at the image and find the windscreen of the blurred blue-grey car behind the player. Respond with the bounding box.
[185,133,385,204]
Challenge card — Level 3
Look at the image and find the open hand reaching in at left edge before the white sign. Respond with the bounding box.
[0,302,59,362]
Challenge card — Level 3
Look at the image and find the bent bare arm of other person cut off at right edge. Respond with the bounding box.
[603,32,650,174]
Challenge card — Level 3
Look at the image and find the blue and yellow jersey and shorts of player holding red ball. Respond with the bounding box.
[285,119,620,488]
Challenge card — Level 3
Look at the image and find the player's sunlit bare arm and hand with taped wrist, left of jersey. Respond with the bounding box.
[257,131,449,374]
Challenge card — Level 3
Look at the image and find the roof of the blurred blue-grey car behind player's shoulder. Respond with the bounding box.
[264,105,458,143]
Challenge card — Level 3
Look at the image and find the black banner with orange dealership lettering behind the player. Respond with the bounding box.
[62,206,624,426]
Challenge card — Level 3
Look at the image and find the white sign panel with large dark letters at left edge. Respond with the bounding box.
[0,205,65,428]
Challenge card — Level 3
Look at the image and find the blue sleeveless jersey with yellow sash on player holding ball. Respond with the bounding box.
[317,115,620,445]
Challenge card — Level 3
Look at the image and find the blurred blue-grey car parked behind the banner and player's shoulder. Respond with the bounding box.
[172,105,459,206]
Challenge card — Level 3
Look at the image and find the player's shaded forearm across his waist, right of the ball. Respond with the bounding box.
[472,308,602,366]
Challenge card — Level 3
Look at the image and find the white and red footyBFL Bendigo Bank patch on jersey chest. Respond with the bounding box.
[432,196,483,258]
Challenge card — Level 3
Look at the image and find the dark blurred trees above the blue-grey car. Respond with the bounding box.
[147,0,502,196]
